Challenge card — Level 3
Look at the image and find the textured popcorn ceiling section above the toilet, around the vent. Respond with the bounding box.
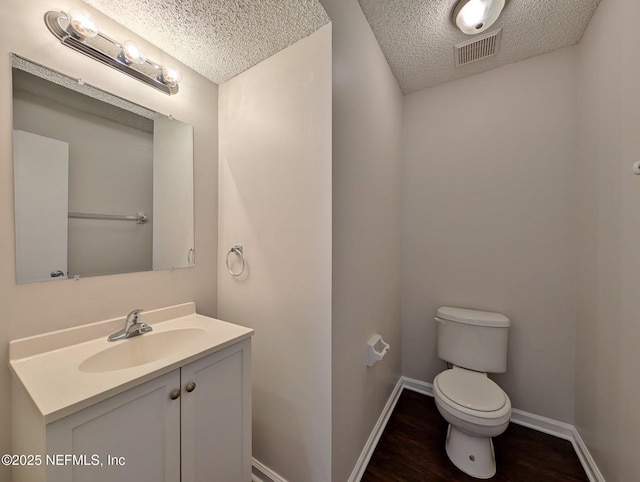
[358,0,600,93]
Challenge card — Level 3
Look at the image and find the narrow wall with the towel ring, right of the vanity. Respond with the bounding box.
[218,25,331,482]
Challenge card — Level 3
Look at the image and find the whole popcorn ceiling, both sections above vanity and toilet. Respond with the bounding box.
[84,0,600,93]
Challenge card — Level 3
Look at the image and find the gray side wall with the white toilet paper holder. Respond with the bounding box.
[321,0,402,481]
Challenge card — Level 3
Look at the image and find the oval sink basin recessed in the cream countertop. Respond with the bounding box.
[79,328,206,373]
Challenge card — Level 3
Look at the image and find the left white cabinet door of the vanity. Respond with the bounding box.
[47,370,180,482]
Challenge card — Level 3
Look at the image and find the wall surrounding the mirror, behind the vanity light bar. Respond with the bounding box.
[0,0,218,480]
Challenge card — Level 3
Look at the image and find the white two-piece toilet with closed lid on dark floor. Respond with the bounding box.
[433,306,511,479]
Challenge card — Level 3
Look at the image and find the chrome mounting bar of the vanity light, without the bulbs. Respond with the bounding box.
[44,11,178,95]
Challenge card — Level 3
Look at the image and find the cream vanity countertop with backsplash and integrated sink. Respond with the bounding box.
[9,303,253,423]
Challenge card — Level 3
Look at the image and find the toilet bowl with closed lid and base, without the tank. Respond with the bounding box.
[433,366,511,479]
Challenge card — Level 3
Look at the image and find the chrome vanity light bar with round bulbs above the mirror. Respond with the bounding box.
[44,8,182,95]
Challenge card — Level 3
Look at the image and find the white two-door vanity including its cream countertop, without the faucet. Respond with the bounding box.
[11,303,253,482]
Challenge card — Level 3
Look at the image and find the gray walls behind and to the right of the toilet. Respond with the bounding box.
[403,0,640,481]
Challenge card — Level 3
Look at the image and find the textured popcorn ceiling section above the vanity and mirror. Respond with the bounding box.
[84,0,330,84]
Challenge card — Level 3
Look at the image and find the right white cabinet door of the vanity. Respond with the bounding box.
[181,340,251,482]
